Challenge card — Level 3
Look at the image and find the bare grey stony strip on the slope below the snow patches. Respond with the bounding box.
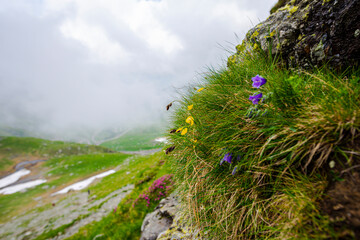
[0,184,134,240]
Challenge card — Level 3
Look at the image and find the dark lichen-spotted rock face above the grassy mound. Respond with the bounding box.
[228,0,360,69]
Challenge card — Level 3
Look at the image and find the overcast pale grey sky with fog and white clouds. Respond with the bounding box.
[0,0,277,139]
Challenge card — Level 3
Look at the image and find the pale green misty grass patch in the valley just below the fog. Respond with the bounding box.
[100,127,163,151]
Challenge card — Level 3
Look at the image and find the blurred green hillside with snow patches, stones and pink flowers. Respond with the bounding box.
[0,135,172,240]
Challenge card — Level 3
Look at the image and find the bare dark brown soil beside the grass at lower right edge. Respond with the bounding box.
[322,170,360,239]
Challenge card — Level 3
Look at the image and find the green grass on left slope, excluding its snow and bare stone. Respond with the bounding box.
[0,137,172,239]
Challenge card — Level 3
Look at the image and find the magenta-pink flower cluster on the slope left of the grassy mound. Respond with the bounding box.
[134,174,174,207]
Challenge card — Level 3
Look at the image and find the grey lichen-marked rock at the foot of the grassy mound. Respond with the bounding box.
[140,194,204,240]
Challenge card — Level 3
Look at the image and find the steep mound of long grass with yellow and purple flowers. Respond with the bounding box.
[167,46,360,239]
